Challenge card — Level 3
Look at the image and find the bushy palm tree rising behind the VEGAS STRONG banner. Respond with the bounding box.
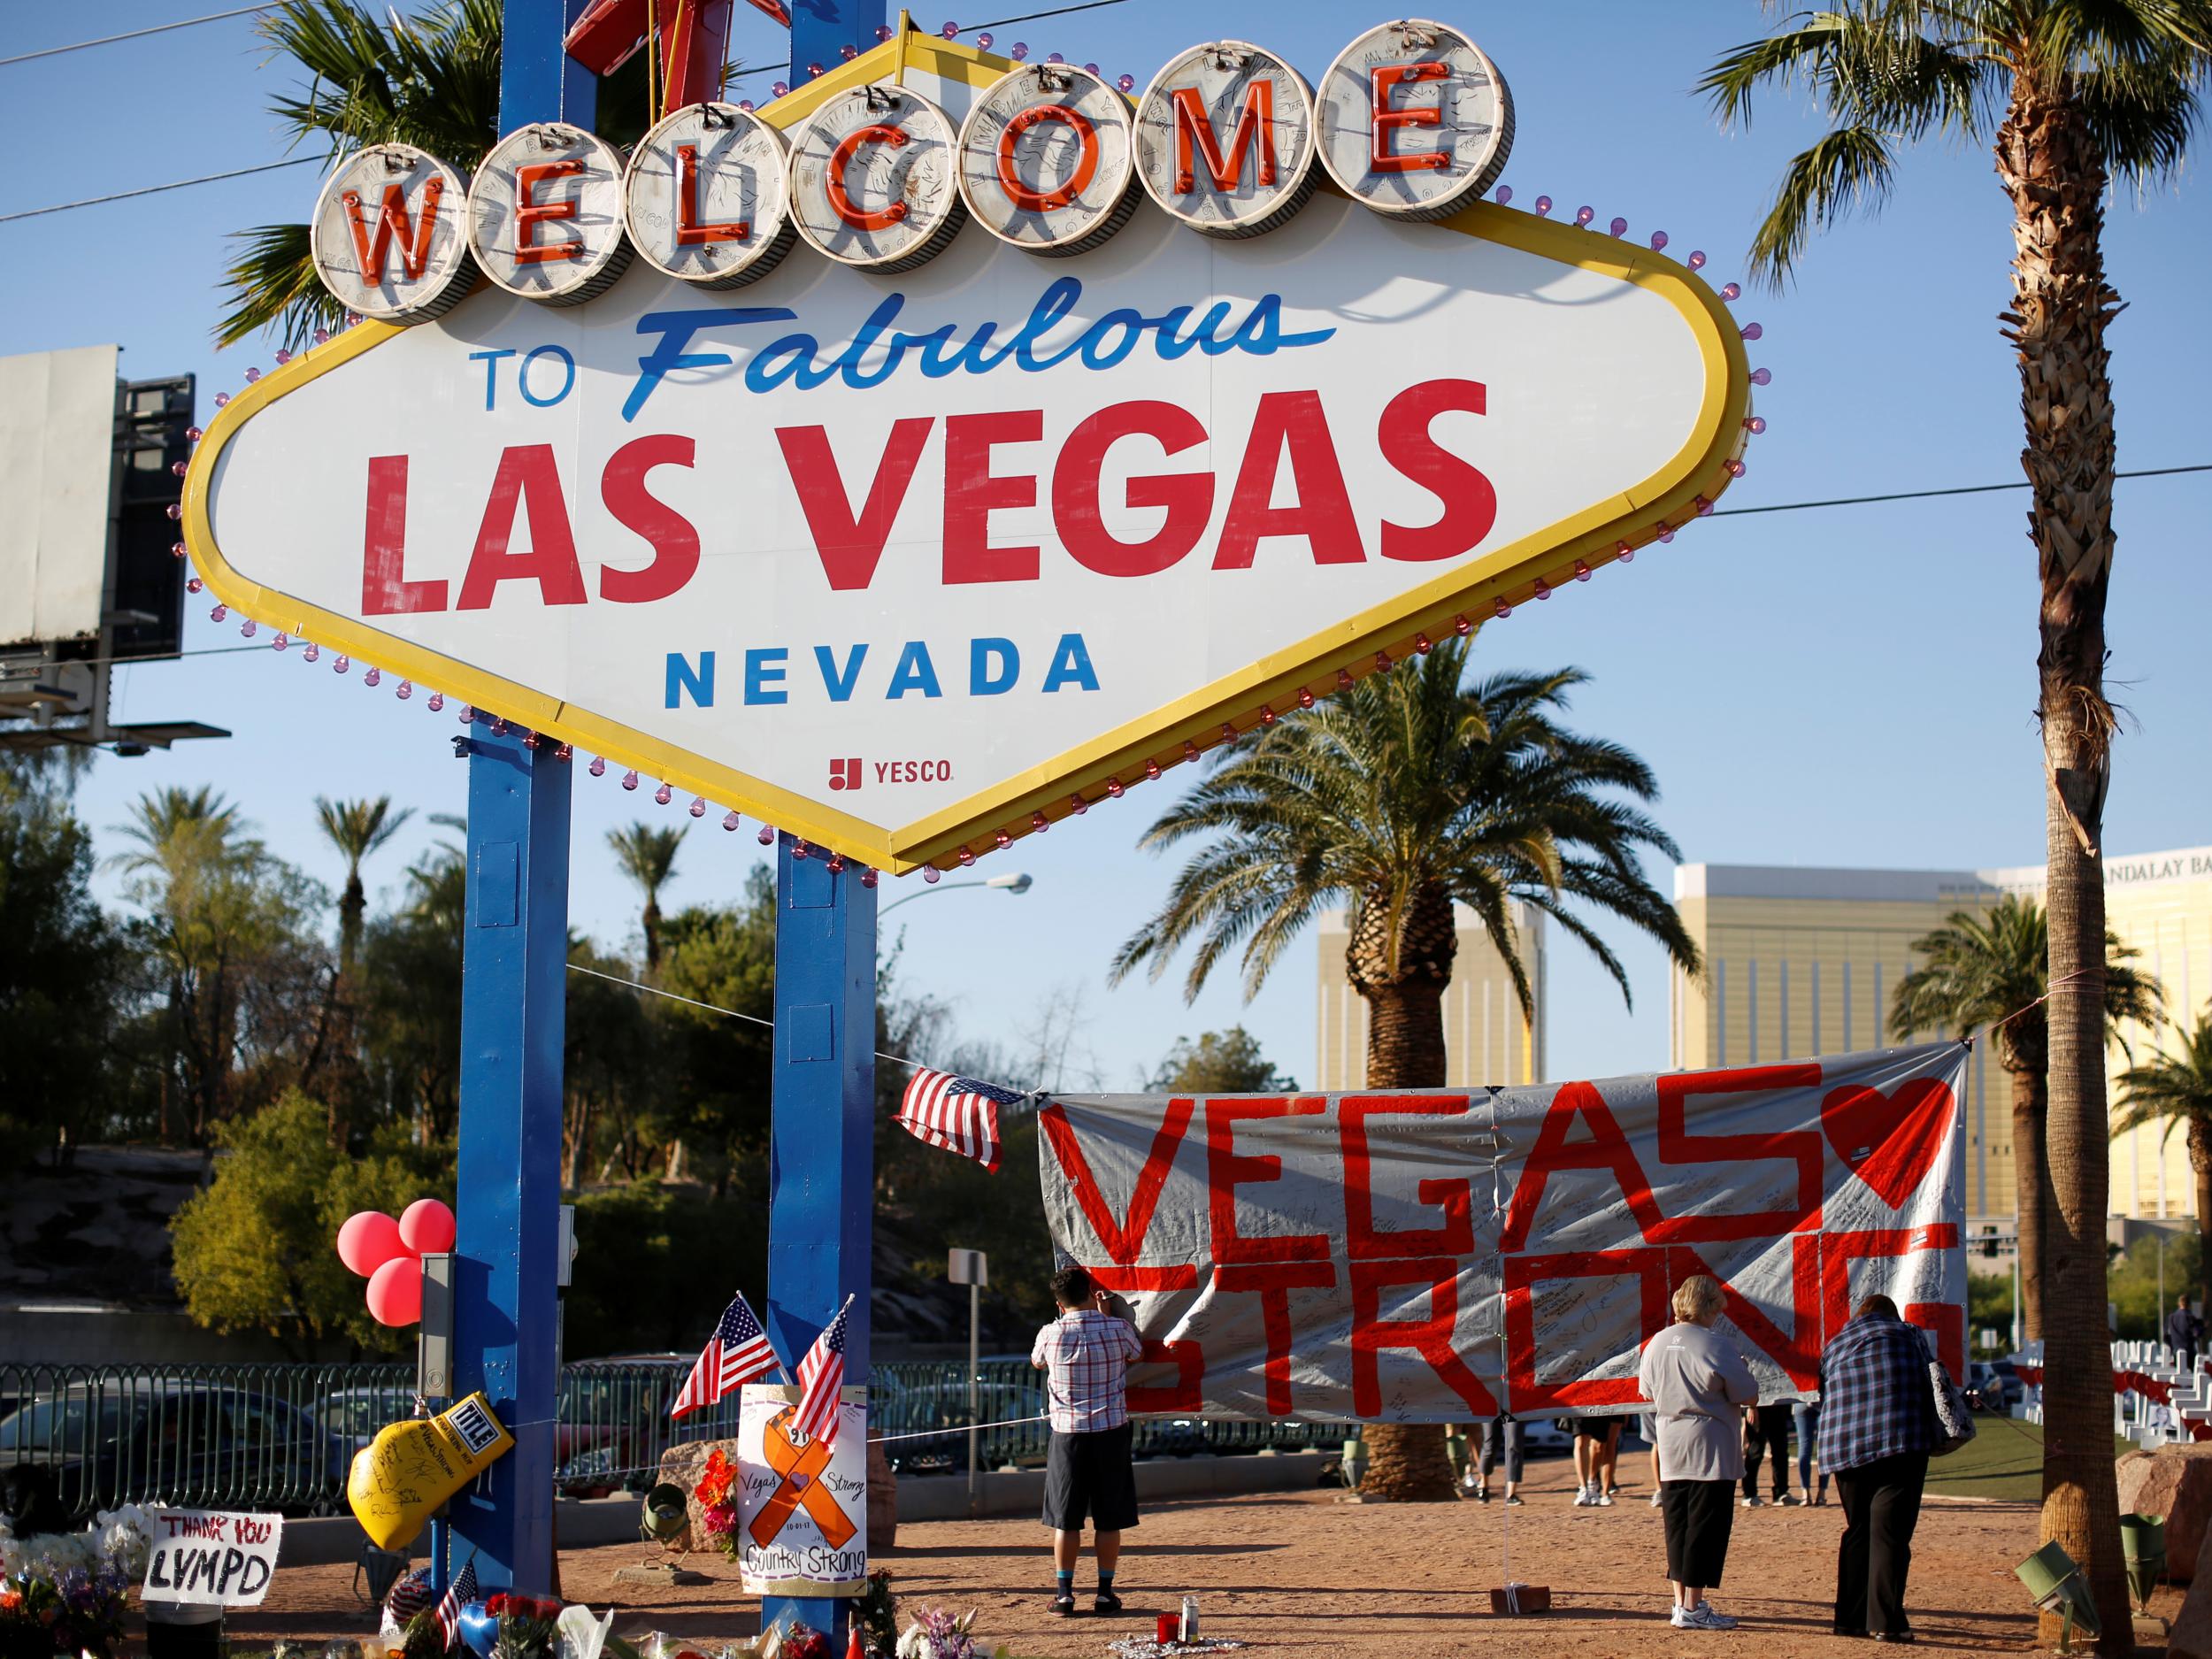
[1113,640,1699,1502]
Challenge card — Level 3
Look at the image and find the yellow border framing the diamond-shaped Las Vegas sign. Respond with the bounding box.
[184,18,1752,874]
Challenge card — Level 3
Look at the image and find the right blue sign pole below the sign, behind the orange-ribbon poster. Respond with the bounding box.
[761,834,876,1653]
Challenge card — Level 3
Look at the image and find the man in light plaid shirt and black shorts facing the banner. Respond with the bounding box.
[1029,1265,1144,1619]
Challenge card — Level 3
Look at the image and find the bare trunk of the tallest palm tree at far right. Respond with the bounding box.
[1998,66,2135,1655]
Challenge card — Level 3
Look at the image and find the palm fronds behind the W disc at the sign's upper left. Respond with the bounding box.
[215,0,500,349]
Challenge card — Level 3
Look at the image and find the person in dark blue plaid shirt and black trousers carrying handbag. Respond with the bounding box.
[1821,1296,1938,1641]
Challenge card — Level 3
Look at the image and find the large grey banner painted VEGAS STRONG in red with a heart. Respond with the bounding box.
[1038,1042,1967,1423]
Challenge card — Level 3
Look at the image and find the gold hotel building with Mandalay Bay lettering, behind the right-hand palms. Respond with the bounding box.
[1668,848,2212,1219]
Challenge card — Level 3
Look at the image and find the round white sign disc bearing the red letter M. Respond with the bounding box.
[1137,40,1314,237]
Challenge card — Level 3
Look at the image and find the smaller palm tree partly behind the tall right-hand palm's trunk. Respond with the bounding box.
[1889,894,2162,1343]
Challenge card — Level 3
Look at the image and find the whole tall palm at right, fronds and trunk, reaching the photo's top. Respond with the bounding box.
[1701,0,2212,1653]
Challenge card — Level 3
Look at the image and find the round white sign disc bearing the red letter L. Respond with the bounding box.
[622,104,799,288]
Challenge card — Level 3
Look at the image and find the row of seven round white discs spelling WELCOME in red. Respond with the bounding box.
[312,20,1513,323]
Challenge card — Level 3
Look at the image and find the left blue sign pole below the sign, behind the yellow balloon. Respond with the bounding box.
[449,724,571,1595]
